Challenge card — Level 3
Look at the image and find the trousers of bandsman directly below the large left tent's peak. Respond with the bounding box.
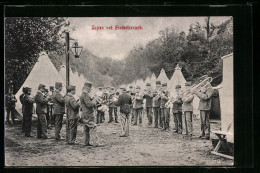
[37,114,47,138]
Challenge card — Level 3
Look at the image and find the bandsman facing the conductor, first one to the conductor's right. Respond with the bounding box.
[133,86,143,125]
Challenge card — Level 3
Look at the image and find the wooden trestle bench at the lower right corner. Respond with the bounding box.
[211,131,234,159]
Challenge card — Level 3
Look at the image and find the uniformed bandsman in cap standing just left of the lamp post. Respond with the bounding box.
[52,82,65,142]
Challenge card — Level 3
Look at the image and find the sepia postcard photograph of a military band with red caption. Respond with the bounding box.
[4,16,235,167]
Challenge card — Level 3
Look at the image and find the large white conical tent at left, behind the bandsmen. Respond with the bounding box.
[15,52,66,115]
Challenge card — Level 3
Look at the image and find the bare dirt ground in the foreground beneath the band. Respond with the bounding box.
[5,111,233,166]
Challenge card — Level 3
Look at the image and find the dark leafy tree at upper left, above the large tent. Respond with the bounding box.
[5,17,68,92]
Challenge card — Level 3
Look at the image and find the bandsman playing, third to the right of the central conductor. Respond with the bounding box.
[153,81,162,128]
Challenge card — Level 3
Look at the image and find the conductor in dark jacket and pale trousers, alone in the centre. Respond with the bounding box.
[115,88,132,137]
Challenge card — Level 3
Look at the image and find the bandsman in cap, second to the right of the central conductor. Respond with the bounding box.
[144,83,153,127]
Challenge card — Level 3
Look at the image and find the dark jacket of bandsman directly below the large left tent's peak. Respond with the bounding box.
[35,91,48,114]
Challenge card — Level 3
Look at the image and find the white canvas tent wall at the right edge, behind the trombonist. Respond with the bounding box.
[219,53,234,133]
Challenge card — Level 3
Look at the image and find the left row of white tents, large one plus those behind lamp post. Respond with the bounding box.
[15,52,91,115]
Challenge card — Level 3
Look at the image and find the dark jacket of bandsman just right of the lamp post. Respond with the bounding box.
[65,93,80,120]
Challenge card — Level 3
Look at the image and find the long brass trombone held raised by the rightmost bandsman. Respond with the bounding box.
[179,75,212,101]
